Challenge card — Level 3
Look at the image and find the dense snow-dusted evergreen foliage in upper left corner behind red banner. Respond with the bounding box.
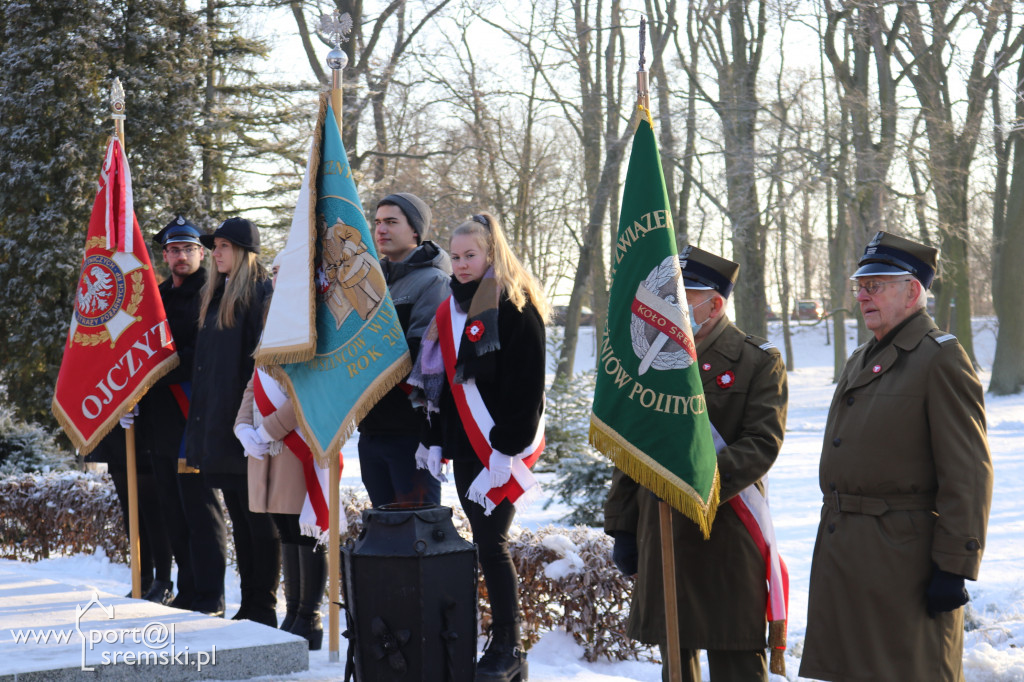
[0,0,203,424]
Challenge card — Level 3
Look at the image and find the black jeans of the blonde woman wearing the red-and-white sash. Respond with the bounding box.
[453,458,519,626]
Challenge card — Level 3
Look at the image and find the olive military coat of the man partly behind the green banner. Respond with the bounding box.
[604,316,788,650]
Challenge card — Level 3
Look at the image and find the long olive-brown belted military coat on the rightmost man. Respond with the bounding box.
[800,311,992,681]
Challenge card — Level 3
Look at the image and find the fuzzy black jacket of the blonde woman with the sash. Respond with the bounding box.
[423,294,546,460]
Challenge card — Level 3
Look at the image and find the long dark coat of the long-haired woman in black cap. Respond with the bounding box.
[185,280,269,489]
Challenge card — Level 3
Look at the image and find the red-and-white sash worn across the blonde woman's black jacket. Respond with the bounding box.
[437,296,544,515]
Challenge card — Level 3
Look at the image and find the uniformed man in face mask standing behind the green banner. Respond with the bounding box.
[604,247,788,682]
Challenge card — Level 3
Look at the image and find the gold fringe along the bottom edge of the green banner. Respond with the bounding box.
[590,414,719,540]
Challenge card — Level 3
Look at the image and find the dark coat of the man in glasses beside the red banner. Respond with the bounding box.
[135,267,206,460]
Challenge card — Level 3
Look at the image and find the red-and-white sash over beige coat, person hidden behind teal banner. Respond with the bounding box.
[253,368,348,543]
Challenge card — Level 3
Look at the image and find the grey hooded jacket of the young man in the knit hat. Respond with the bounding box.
[359,242,452,435]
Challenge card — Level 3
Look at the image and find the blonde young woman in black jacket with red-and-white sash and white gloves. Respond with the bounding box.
[410,213,550,682]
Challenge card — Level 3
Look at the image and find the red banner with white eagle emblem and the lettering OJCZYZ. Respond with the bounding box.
[52,136,178,454]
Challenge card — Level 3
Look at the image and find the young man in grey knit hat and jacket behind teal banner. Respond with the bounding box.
[359,193,452,507]
